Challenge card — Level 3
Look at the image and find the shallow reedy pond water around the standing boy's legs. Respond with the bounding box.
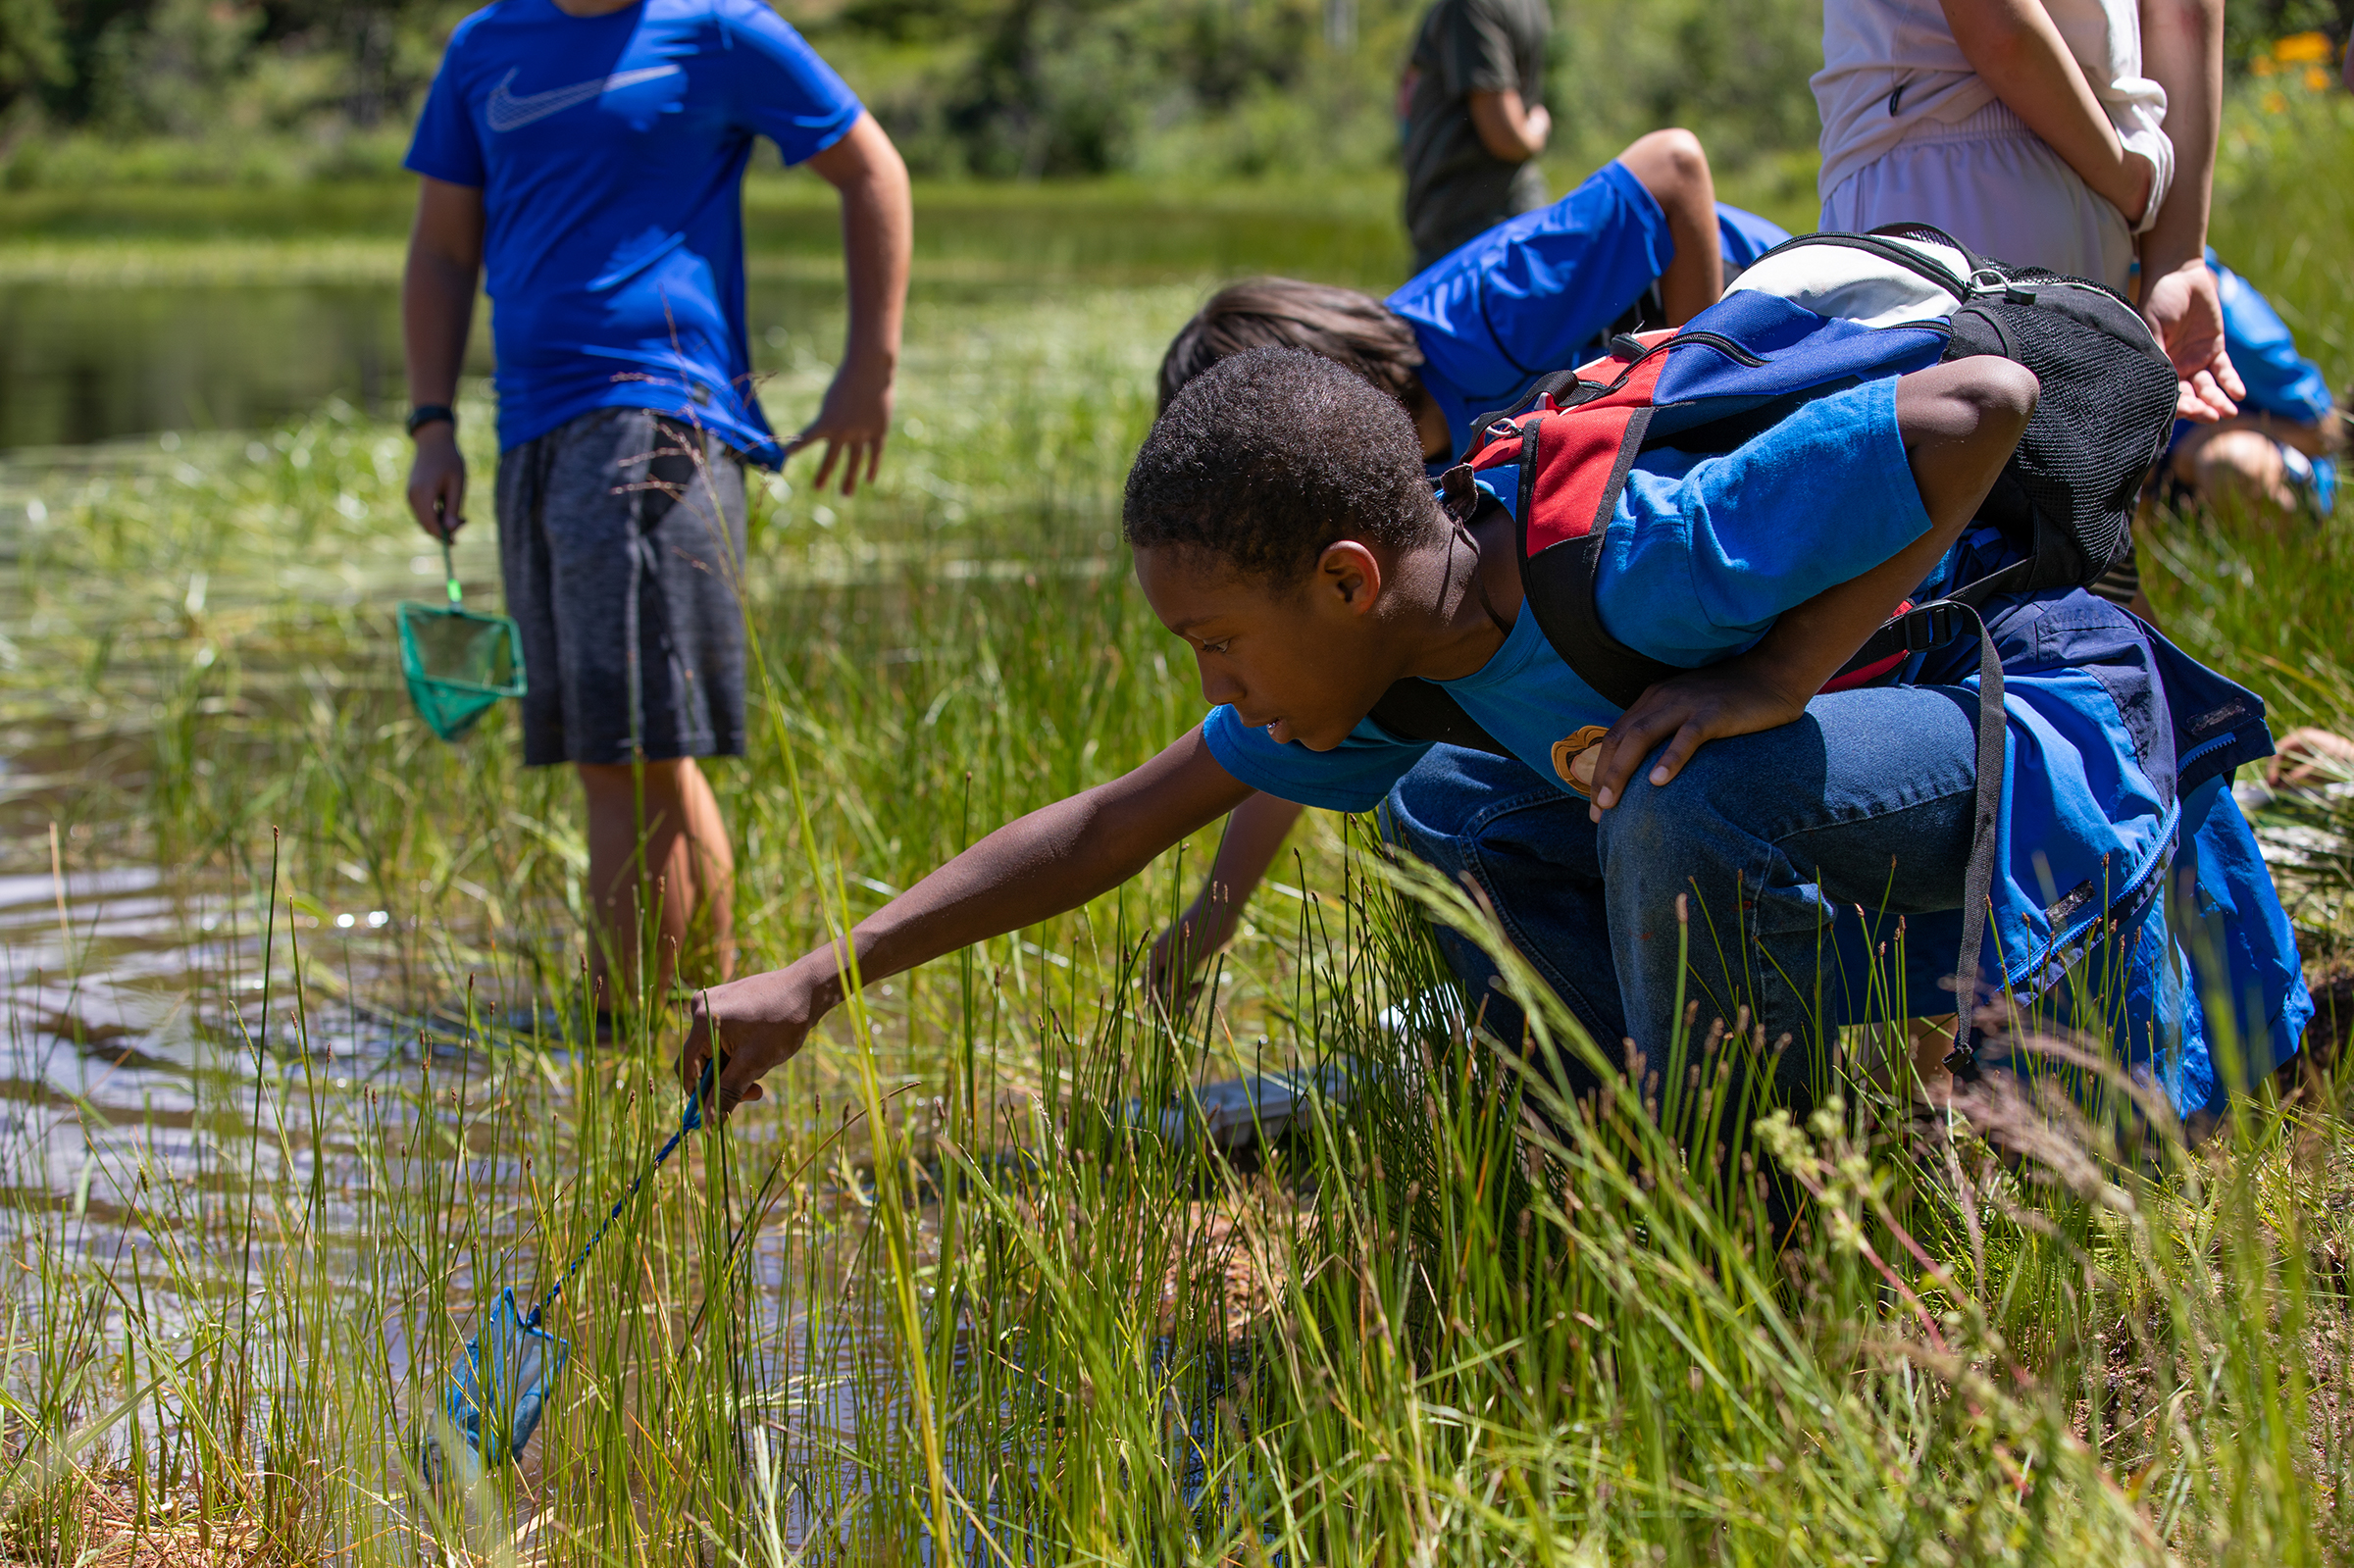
[0,191,1396,1531]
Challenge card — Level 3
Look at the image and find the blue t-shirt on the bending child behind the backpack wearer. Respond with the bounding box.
[1384,160,1789,454]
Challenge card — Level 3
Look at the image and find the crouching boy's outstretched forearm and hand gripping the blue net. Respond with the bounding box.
[678,730,1250,1114]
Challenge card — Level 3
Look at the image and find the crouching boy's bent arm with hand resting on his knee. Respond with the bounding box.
[1579,356,2036,822]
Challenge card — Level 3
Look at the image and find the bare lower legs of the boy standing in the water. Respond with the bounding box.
[579,758,735,1005]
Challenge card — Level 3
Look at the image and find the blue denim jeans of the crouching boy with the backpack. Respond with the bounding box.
[1384,687,1977,1104]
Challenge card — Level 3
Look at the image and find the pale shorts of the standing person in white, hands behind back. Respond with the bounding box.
[1822,104,2135,297]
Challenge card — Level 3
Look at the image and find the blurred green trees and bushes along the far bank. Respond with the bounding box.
[0,0,2354,190]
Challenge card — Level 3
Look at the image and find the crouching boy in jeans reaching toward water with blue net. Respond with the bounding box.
[681,348,2305,1130]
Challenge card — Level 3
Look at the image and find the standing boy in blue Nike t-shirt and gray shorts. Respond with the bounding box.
[400,0,911,1003]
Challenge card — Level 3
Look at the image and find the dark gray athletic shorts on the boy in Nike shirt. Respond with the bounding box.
[499,407,743,768]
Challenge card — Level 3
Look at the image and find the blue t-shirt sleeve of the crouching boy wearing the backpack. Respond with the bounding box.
[1594,377,1928,669]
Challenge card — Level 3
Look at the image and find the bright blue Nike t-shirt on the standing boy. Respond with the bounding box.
[407,0,859,464]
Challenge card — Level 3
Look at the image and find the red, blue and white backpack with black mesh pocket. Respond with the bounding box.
[1372,226,2175,1057]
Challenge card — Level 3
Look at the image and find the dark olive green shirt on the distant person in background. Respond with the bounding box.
[1401,0,1554,271]
